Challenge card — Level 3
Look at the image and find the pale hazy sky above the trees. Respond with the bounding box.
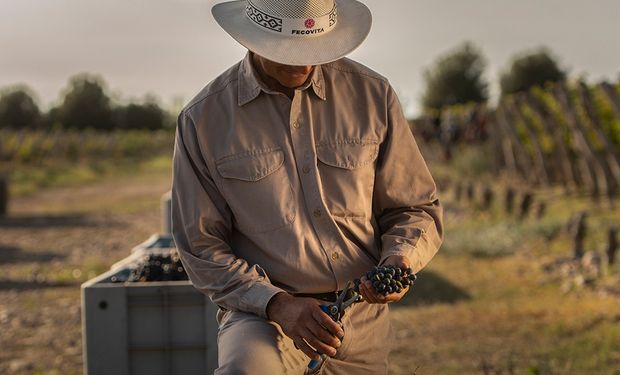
[0,0,620,115]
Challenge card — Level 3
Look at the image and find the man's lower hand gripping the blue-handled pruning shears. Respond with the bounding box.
[267,292,344,360]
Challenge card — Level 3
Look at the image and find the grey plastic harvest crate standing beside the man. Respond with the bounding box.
[82,254,218,375]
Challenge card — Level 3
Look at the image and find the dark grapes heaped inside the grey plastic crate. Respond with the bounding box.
[128,251,188,281]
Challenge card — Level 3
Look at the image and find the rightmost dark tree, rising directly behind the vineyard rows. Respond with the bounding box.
[500,47,566,96]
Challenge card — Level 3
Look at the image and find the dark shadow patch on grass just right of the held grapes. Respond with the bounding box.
[390,271,471,308]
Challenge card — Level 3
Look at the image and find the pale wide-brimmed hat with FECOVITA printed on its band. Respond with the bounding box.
[211,0,372,65]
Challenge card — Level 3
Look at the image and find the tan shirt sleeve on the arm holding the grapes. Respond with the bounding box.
[373,87,443,272]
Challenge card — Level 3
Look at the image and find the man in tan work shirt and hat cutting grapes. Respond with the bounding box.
[172,0,442,374]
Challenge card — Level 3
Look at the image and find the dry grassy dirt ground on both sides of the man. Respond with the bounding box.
[0,173,620,375]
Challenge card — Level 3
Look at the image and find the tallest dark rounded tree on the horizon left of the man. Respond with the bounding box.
[52,74,116,130]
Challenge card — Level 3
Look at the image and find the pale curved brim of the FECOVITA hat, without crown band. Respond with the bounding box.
[211,0,372,65]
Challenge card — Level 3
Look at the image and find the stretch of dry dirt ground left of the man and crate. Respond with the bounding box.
[0,176,170,375]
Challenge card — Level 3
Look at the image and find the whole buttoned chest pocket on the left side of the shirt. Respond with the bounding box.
[216,149,295,232]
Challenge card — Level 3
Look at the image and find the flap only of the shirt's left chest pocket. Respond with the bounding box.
[216,149,284,181]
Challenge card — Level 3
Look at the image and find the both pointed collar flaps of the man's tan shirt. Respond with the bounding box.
[237,51,326,107]
